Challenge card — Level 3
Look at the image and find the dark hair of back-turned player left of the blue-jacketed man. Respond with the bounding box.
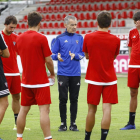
[28,11,42,27]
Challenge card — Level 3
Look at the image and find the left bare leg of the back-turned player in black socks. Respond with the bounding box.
[86,104,97,132]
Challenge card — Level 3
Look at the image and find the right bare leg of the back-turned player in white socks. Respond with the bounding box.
[39,105,51,137]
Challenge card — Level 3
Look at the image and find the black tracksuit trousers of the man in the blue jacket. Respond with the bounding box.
[57,75,81,123]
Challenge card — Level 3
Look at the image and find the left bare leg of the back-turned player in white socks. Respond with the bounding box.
[17,106,30,134]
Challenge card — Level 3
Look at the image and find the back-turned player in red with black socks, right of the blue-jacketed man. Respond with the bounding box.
[83,11,120,140]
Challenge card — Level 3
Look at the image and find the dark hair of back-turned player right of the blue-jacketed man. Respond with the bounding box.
[97,11,111,28]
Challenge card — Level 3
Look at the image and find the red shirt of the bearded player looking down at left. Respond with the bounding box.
[0,31,20,76]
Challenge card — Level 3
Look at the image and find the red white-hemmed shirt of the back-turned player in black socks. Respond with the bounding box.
[83,31,120,85]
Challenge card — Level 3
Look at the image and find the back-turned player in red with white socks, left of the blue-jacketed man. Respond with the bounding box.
[17,12,55,140]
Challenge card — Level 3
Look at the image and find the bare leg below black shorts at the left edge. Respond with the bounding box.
[0,96,9,124]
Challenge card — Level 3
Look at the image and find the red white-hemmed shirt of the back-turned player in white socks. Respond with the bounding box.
[17,30,52,88]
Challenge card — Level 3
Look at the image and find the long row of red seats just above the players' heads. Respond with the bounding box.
[37,2,140,13]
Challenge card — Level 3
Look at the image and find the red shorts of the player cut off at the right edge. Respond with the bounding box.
[127,68,140,88]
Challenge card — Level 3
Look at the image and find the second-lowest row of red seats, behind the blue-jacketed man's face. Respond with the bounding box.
[16,20,125,29]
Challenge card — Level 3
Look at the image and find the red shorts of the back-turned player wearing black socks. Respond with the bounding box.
[87,84,118,105]
